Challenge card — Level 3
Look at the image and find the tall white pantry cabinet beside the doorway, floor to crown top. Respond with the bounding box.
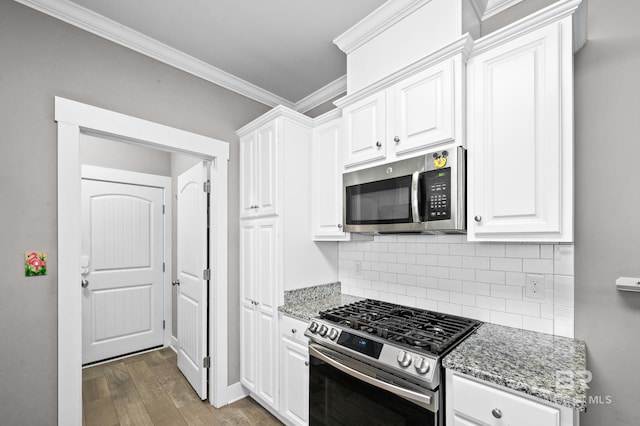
[237,106,338,412]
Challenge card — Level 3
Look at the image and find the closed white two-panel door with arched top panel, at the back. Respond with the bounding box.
[81,179,164,364]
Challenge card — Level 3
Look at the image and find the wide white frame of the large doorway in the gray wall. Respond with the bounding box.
[54,96,229,426]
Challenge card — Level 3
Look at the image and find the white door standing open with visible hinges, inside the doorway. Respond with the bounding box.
[177,162,208,399]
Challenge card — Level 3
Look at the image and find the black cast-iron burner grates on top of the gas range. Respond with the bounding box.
[320,299,480,355]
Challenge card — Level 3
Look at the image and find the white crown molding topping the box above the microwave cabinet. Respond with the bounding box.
[333,0,431,54]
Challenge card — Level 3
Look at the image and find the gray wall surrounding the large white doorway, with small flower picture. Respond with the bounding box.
[0,0,270,425]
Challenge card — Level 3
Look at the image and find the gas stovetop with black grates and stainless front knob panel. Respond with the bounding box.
[305,299,481,389]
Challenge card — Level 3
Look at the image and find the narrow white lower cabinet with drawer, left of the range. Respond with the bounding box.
[279,315,309,425]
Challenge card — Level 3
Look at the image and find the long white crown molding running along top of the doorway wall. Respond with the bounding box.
[14,0,295,108]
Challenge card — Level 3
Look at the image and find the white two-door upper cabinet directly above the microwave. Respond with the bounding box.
[336,36,471,170]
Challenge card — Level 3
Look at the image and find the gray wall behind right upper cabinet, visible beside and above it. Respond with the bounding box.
[483,0,640,426]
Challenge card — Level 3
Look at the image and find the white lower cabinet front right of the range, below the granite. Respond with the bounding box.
[446,370,578,426]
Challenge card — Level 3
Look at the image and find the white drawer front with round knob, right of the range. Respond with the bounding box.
[450,374,560,426]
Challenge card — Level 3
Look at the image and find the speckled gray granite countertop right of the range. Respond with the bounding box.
[443,324,587,412]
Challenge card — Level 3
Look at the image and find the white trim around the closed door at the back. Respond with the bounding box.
[81,164,173,346]
